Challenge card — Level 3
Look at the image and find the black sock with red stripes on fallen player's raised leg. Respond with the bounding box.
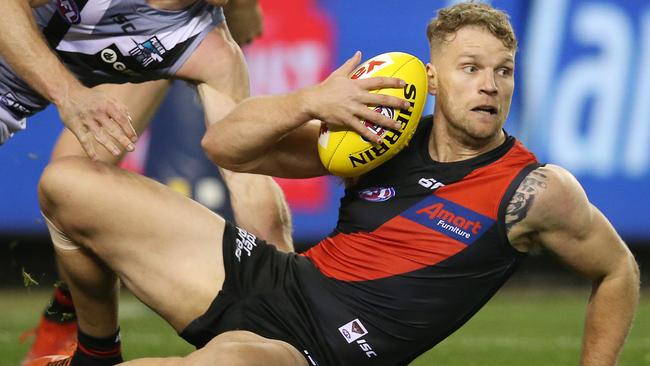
[70,329,124,366]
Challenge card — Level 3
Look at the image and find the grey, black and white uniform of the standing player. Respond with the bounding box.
[0,0,224,144]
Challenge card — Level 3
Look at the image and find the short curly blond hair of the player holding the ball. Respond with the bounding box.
[427,2,517,52]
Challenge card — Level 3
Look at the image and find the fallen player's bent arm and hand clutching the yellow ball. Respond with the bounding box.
[202,53,408,178]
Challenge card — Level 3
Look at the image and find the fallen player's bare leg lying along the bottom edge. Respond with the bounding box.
[123,331,307,366]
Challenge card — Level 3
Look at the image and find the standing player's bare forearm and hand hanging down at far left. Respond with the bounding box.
[0,0,137,159]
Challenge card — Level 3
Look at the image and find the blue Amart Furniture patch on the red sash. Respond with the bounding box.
[401,195,494,245]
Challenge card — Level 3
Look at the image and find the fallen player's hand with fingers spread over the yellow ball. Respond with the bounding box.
[302,52,410,143]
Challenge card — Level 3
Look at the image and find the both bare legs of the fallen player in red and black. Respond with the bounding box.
[39,158,306,365]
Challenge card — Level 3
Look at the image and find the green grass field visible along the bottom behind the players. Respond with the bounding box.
[0,286,650,366]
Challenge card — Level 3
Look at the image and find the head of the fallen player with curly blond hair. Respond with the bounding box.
[427,3,517,142]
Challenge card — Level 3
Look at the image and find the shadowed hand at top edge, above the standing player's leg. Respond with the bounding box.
[223,0,262,46]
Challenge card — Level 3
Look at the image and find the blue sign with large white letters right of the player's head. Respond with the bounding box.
[518,0,650,239]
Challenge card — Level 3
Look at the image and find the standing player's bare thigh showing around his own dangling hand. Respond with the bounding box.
[52,80,170,164]
